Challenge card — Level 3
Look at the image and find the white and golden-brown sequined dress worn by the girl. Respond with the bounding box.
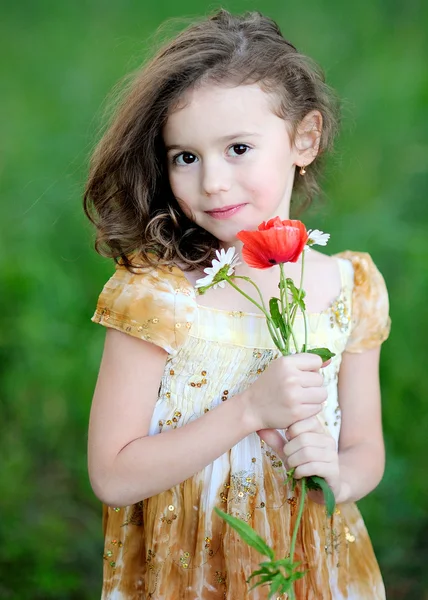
[92,251,390,600]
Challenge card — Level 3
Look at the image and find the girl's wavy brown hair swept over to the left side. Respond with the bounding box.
[84,10,339,270]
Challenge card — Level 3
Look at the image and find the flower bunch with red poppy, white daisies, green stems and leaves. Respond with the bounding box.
[196,217,335,599]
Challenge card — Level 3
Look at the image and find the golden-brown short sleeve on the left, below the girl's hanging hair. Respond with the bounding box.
[92,264,196,355]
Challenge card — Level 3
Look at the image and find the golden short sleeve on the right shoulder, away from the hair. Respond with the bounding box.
[337,250,391,352]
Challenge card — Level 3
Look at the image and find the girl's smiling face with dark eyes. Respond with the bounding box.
[163,84,298,245]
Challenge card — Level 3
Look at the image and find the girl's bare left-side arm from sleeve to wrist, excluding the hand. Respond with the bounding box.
[88,329,252,506]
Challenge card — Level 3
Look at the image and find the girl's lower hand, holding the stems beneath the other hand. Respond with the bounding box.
[283,417,341,504]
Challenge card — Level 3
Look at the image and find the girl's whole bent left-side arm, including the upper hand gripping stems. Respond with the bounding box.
[88,329,327,506]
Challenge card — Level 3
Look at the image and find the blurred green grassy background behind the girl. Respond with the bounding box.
[0,0,428,600]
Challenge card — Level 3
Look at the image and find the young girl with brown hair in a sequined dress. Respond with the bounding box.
[85,11,389,600]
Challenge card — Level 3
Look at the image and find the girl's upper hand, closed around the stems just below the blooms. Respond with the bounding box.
[245,353,327,431]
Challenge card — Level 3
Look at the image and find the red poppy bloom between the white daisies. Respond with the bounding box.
[236,217,308,269]
